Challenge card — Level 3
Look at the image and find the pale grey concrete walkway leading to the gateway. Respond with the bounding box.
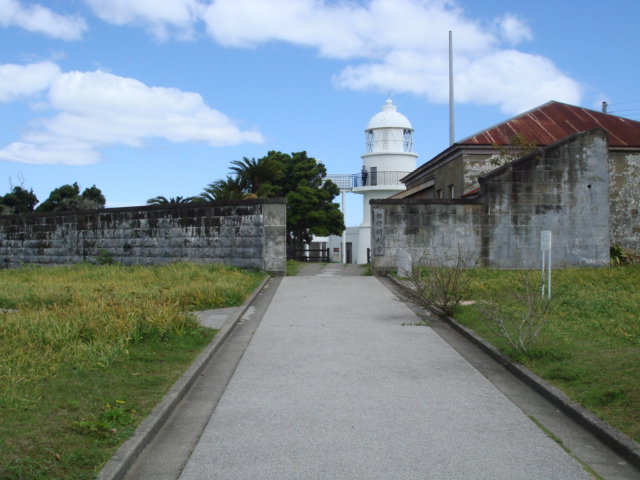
[180,274,591,480]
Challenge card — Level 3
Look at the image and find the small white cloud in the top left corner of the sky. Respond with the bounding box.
[0,0,87,40]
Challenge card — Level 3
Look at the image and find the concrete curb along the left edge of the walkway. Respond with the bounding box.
[98,277,271,480]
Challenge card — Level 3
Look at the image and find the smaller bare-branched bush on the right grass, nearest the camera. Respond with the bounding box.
[478,269,551,353]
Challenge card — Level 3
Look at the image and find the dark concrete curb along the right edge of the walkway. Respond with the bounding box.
[386,275,640,469]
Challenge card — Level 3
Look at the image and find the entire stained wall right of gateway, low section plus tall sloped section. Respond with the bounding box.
[371,130,609,274]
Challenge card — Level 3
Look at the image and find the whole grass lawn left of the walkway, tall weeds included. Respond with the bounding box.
[0,263,264,480]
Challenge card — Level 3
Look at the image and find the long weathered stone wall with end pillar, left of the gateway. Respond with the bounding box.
[0,199,286,275]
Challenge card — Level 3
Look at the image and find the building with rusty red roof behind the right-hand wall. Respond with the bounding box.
[393,101,640,251]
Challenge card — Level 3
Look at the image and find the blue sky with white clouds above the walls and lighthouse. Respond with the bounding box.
[0,0,640,226]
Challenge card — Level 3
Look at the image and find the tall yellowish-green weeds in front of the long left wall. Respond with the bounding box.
[0,263,261,400]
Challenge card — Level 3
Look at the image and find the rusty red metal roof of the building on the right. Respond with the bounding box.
[457,101,640,147]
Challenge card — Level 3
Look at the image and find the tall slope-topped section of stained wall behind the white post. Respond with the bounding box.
[480,130,609,268]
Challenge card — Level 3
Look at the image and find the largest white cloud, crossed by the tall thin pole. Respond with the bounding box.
[203,0,582,114]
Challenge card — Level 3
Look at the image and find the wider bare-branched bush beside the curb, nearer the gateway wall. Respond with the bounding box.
[392,246,477,315]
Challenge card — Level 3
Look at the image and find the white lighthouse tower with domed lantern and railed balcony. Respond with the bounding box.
[351,99,418,263]
